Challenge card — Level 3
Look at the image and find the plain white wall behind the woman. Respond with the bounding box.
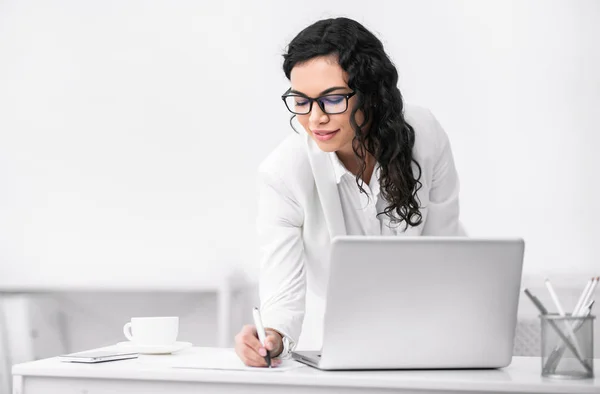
[0,0,600,378]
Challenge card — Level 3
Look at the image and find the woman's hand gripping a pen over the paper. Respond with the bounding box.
[235,324,283,367]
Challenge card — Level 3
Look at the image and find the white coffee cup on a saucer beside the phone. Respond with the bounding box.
[123,316,179,346]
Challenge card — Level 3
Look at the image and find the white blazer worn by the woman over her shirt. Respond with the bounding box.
[257,106,463,350]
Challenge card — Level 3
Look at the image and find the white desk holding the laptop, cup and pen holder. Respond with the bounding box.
[13,348,600,394]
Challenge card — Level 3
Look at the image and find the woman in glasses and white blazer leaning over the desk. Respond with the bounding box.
[235,18,461,366]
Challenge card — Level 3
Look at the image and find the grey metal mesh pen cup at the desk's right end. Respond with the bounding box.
[540,314,595,379]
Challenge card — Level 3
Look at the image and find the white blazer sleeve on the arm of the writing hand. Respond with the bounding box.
[257,171,306,350]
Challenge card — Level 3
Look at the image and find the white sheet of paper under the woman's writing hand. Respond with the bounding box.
[171,348,305,372]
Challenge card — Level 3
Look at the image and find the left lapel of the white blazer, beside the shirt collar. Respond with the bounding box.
[306,134,346,239]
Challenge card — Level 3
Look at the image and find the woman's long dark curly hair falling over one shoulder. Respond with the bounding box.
[283,18,423,230]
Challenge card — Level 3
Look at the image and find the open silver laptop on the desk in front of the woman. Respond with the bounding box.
[292,236,524,370]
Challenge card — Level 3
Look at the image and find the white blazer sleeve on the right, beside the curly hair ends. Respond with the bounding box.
[423,112,466,236]
